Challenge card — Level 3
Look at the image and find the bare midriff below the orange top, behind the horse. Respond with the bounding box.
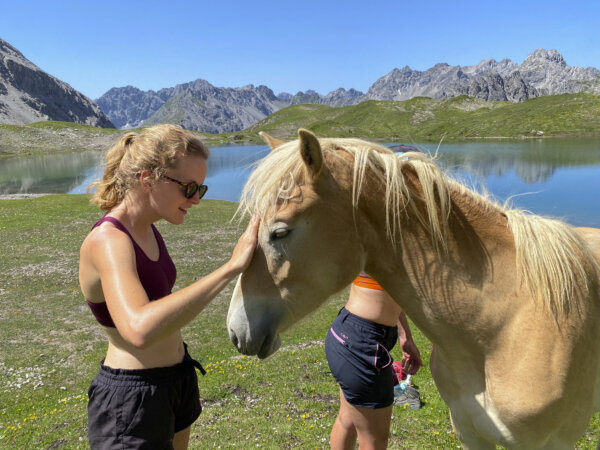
[346,284,402,327]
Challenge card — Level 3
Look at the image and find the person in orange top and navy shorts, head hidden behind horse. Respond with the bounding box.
[325,274,423,450]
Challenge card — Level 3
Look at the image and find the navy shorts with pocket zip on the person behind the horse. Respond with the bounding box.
[325,308,398,409]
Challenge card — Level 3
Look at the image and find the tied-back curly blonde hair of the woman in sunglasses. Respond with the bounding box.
[87,124,209,211]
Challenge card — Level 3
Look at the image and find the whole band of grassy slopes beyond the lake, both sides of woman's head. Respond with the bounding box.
[0,94,600,157]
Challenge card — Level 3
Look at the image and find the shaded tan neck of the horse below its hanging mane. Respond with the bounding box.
[359,171,514,350]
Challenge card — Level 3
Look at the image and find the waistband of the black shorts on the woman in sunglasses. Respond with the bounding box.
[96,343,206,387]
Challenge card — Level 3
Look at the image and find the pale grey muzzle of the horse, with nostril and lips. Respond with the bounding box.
[227,275,281,359]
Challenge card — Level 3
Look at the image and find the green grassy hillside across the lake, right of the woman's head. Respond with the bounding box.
[237,94,600,141]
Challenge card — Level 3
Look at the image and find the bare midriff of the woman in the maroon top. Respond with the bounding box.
[102,327,184,369]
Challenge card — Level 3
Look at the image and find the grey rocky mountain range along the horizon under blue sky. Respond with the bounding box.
[0,35,600,133]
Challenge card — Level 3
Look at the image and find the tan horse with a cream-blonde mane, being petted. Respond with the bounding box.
[227,130,600,450]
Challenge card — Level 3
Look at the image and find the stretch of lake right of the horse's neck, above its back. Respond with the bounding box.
[418,139,600,227]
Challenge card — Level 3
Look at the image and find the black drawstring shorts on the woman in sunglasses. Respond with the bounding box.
[88,346,203,450]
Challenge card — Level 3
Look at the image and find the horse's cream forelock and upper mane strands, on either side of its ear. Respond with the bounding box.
[238,138,450,249]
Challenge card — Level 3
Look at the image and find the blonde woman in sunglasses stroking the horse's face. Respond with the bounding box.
[79,125,258,449]
